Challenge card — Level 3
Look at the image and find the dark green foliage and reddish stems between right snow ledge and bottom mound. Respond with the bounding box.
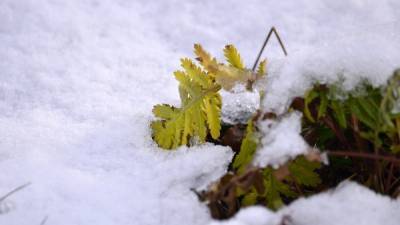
[292,71,400,195]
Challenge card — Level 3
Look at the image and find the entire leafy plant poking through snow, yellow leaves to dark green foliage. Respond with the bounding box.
[151,40,400,219]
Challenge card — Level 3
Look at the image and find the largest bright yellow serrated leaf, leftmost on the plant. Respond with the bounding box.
[151,68,221,149]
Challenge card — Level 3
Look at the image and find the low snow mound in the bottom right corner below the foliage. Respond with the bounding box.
[210,181,400,225]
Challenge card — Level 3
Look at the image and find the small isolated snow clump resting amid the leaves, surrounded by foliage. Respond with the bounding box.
[253,112,310,167]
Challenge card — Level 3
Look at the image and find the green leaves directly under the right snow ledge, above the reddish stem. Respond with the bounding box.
[303,72,400,154]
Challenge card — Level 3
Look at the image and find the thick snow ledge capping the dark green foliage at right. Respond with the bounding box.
[263,20,400,112]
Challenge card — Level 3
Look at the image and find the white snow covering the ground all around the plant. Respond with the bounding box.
[0,0,400,225]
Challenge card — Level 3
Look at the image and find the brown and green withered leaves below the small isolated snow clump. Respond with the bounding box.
[205,116,321,218]
